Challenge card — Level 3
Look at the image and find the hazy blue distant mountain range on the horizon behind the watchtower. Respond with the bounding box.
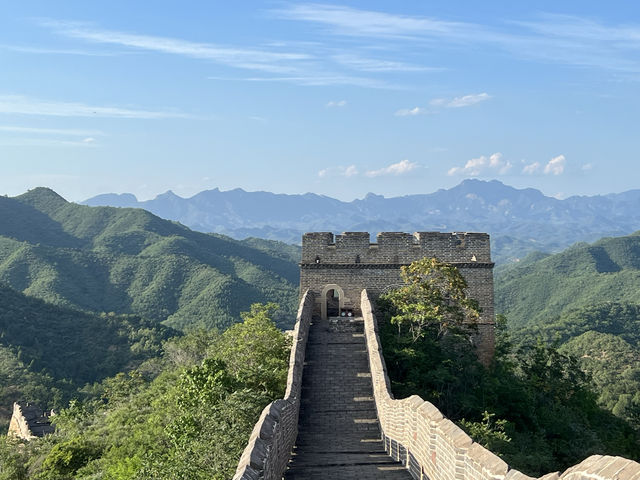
[83,180,640,263]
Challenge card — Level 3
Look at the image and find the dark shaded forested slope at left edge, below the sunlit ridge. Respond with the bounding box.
[0,284,178,427]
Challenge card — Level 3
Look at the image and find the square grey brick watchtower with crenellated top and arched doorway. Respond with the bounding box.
[300,232,495,363]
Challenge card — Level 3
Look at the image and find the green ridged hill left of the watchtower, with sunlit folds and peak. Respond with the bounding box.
[0,188,299,329]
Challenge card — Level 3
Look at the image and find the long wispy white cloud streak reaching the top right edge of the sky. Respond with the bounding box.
[273,3,640,73]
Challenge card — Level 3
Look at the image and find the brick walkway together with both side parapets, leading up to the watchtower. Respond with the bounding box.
[233,290,640,480]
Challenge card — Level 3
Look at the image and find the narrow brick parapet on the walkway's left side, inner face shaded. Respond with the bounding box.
[233,291,314,480]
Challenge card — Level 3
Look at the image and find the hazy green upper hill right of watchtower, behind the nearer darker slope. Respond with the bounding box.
[495,233,640,328]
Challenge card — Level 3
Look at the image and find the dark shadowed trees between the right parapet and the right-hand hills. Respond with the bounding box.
[378,258,640,475]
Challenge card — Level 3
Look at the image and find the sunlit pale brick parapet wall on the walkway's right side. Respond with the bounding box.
[361,290,640,480]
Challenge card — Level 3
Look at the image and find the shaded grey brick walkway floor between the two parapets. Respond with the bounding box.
[284,318,411,480]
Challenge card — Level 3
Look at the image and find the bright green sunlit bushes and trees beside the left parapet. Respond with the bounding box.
[0,304,290,480]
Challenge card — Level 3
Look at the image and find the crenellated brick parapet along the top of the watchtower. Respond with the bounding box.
[301,232,491,265]
